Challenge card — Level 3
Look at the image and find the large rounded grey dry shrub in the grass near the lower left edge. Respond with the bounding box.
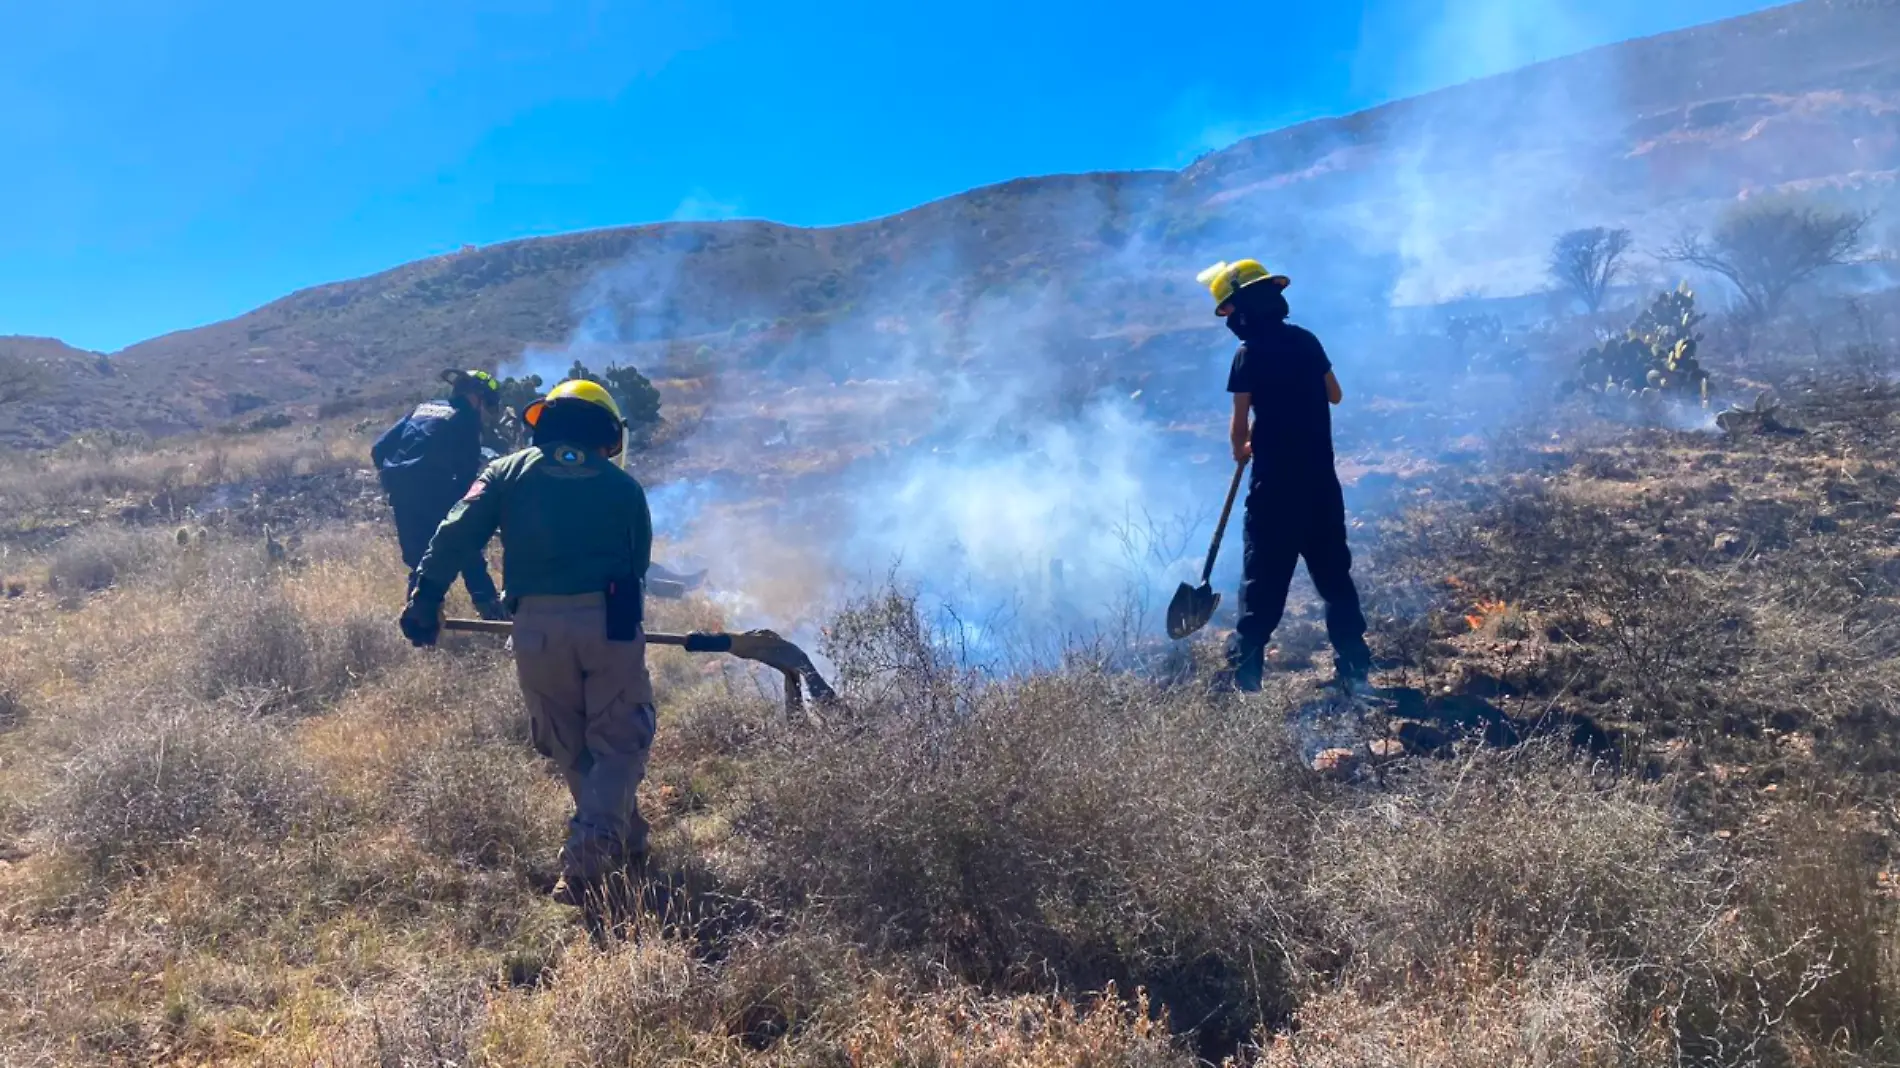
[40,703,321,874]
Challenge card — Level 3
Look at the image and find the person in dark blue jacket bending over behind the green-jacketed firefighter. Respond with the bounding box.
[371,371,507,620]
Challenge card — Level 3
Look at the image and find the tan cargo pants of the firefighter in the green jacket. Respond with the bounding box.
[515,593,656,880]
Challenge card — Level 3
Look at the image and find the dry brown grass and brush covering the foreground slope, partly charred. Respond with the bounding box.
[0,351,1900,1068]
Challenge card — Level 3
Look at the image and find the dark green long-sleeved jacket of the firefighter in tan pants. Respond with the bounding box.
[416,445,654,599]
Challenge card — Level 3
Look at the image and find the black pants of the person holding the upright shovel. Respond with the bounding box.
[1233,477,1372,671]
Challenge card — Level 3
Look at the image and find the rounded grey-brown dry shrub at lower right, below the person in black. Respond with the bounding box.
[1307,758,1725,981]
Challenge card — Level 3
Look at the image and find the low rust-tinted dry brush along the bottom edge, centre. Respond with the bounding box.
[486,933,1195,1068]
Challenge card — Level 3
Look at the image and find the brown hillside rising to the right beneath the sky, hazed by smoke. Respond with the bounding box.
[0,0,1900,445]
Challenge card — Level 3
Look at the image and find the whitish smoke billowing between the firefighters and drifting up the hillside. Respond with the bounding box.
[505,0,1839,657]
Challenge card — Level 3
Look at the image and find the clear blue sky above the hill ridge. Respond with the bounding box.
[0,0,1773,352]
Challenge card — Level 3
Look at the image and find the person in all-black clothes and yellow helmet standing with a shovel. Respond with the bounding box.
[1201,260,1372,690]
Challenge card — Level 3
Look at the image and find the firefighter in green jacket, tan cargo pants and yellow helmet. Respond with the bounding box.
[401,380,656,905]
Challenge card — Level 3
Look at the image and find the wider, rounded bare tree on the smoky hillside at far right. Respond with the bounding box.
[1663,201,1873,319]
